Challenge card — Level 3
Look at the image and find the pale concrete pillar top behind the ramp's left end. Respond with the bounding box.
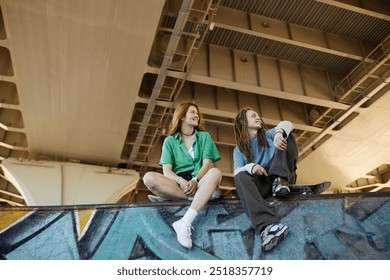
[1,158,139,206]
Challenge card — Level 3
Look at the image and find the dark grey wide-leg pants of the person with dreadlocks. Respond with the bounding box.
[234,135,298,232]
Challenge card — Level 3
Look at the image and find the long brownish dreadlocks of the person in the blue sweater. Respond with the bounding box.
[234,107,268,162]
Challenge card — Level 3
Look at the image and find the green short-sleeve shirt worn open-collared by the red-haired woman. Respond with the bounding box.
[160,129,221,176]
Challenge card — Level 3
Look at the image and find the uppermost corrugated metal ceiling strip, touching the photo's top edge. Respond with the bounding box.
[221,0,390,45]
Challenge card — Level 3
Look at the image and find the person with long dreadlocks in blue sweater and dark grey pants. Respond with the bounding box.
[233,108,298,251]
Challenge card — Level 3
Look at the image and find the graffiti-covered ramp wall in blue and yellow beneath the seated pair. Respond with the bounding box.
[0,192,390,260]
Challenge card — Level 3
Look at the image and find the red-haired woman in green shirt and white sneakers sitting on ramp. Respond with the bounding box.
[143,102,222,248]
